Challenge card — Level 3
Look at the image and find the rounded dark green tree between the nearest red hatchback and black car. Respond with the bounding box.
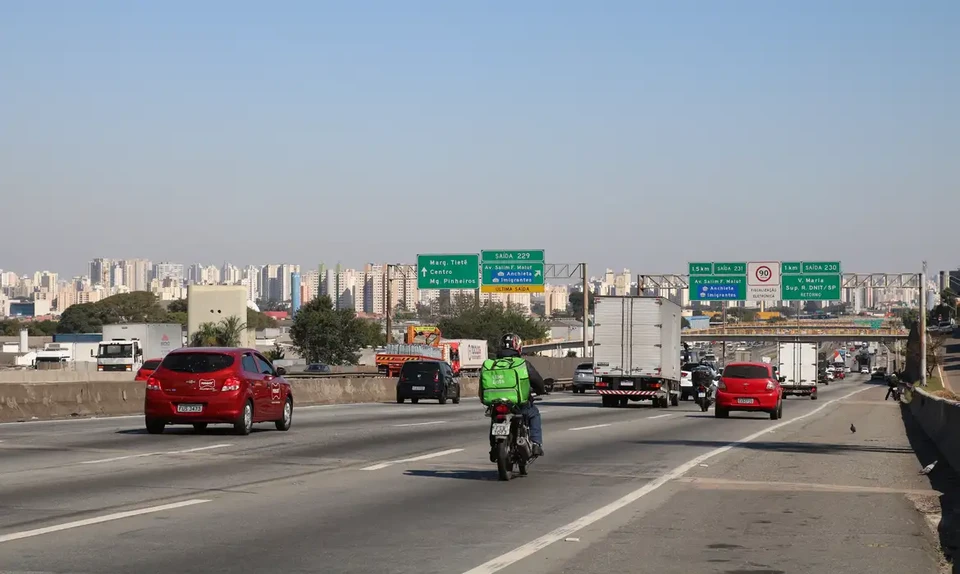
[290,295,369,365]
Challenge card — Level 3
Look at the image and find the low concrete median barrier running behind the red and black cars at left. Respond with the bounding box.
[0,377,478,422]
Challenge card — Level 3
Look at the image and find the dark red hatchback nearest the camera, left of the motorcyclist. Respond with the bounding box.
[144,347,293,435]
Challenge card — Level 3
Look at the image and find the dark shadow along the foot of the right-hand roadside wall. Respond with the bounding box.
[900,404,960,572]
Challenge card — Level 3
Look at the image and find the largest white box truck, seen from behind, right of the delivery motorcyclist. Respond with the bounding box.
[593,296,681,408]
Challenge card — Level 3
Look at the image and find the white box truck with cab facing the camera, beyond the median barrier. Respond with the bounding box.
[96,323,183,372]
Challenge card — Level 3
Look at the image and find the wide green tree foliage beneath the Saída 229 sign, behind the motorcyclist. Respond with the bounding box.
[437,302,547,352]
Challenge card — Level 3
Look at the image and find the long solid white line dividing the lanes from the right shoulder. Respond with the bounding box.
[464,387,874,574]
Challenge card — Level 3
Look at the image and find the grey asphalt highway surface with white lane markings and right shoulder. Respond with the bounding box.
[0,375,938,574]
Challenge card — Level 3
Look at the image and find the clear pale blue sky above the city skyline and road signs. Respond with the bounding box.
[0,0,960,280]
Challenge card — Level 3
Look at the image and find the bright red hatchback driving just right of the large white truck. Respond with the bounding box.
[714,363,783,420]
